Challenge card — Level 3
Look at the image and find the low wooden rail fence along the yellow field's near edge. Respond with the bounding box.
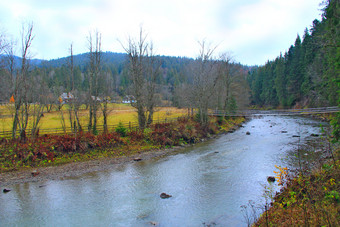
[0,117,179,138]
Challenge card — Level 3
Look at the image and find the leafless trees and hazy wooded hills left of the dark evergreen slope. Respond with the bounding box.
[0,23,249,138]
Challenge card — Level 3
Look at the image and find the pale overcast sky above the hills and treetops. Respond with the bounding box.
[0,0,321,65]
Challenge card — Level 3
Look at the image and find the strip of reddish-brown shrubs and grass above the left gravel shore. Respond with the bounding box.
[0,117,244,172]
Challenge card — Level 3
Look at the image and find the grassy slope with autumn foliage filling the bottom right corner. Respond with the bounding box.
[254,145,340,226]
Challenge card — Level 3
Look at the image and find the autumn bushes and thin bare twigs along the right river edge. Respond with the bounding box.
[248,113,340,226]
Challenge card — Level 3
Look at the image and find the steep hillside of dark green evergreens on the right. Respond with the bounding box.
[248,0,340,107]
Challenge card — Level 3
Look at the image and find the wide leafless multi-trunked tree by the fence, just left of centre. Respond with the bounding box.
[123,28,160,130]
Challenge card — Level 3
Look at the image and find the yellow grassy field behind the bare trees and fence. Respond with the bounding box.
[0,104,186,136]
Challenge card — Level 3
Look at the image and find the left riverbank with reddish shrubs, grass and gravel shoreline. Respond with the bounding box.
[0,118,245,187]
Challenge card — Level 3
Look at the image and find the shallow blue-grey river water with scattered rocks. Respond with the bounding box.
[0,116,320,226]
